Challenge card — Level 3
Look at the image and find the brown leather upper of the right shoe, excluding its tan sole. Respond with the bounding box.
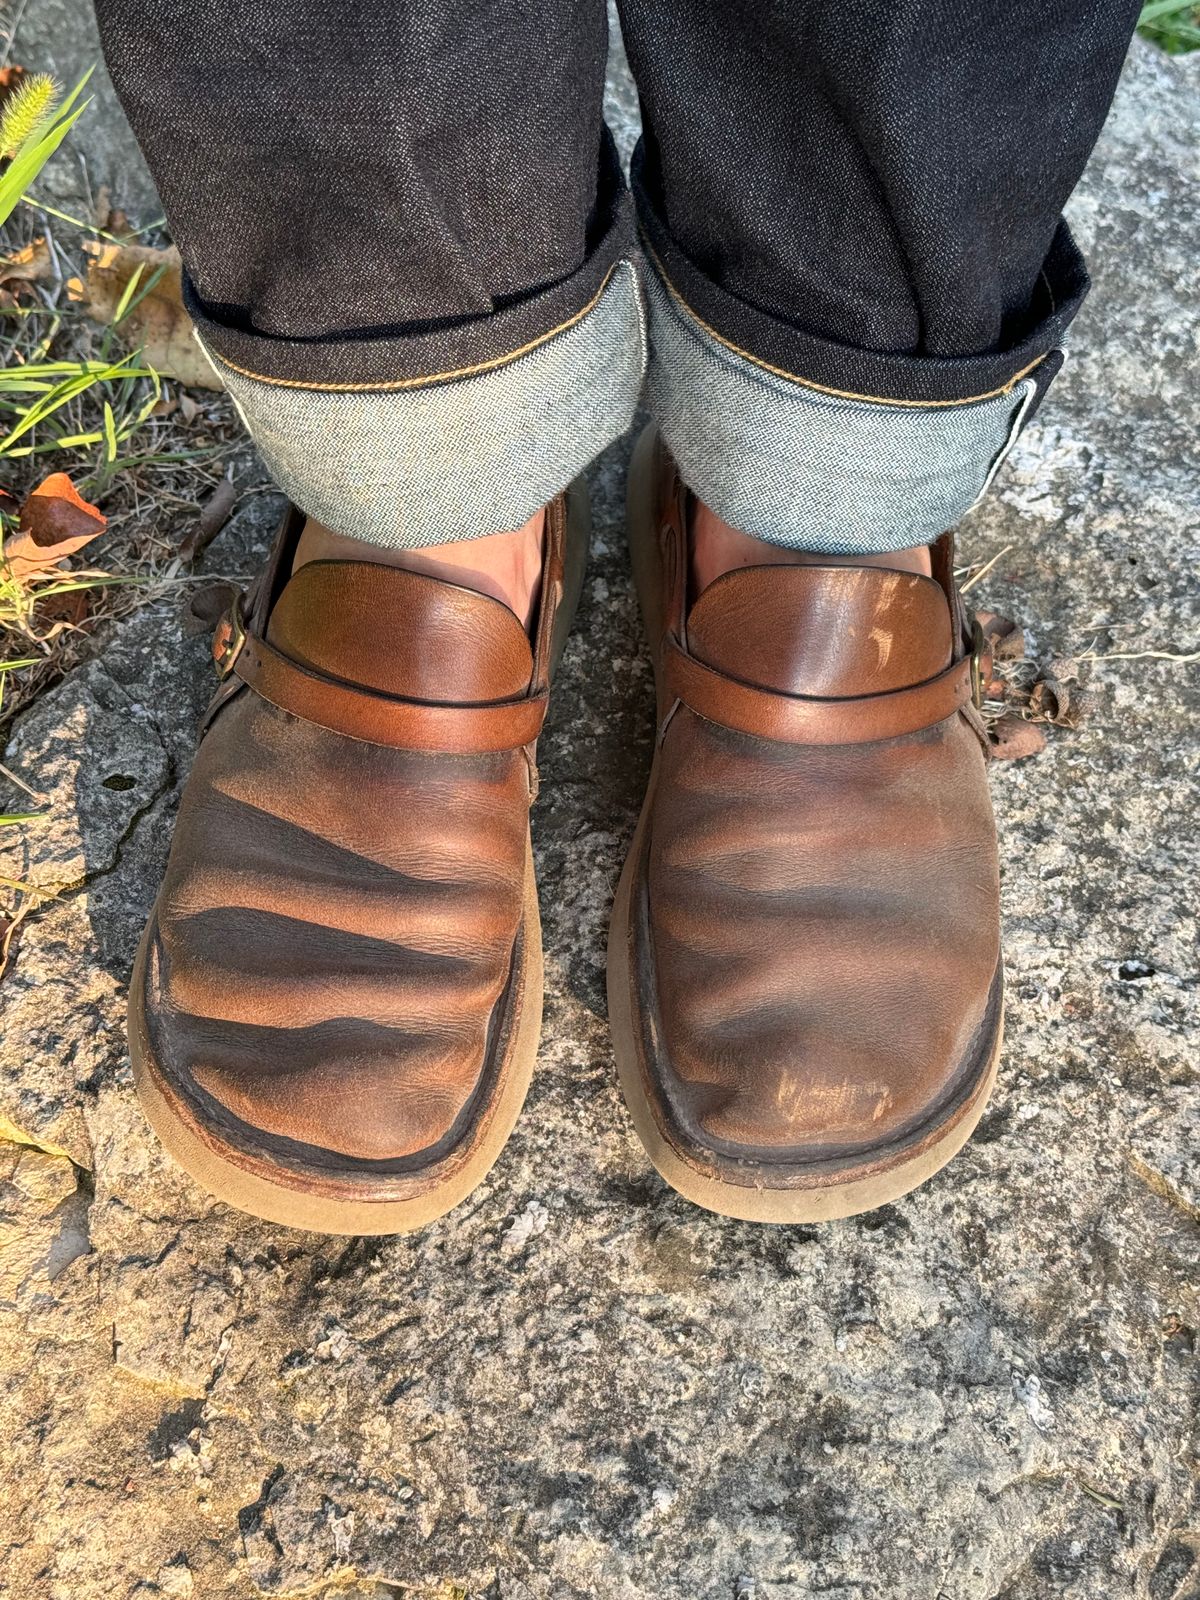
[635,453,1000,1166]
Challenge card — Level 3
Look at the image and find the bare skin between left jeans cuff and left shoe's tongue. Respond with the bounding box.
[291,509,546,632]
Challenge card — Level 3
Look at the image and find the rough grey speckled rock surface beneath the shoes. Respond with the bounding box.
[0,21,1200,1600]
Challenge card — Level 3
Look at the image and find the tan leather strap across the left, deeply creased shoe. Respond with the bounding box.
[229,634,549,755]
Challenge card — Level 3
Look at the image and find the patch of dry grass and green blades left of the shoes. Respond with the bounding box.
[0,100,261,953]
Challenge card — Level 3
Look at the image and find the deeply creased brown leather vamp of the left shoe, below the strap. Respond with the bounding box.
[147,694,528,1158]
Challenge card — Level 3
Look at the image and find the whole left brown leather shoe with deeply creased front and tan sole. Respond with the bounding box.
[130,485,587,1234]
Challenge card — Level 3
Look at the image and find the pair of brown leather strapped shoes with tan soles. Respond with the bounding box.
[130,432,1002,1234]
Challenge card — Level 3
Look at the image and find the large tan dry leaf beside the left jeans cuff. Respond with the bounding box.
[80,242,222,389]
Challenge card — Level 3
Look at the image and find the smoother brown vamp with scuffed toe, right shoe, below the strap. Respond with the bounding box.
[646,709,998,1158]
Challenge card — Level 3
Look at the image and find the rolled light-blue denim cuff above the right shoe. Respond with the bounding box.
[640,179,1088,555]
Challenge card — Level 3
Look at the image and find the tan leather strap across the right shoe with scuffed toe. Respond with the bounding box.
[664,638,971,744]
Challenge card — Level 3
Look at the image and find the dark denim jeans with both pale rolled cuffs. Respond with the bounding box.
[98,0,1138,549]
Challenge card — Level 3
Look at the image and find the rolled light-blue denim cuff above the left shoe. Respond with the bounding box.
[189,206,646,550]
